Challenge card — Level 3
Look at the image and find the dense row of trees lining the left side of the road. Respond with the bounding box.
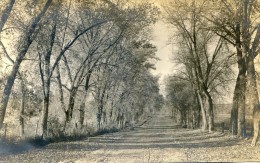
[0,0,162,138]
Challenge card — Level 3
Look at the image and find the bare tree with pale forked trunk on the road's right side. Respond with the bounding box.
[166,1,236,131]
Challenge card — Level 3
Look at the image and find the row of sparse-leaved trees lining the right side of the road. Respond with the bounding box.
[164,0,260,140]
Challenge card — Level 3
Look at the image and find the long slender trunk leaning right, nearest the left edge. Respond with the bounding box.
[0,0,52,128]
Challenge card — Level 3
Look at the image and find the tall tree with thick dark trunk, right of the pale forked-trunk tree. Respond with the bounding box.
[205,0,260,137]
